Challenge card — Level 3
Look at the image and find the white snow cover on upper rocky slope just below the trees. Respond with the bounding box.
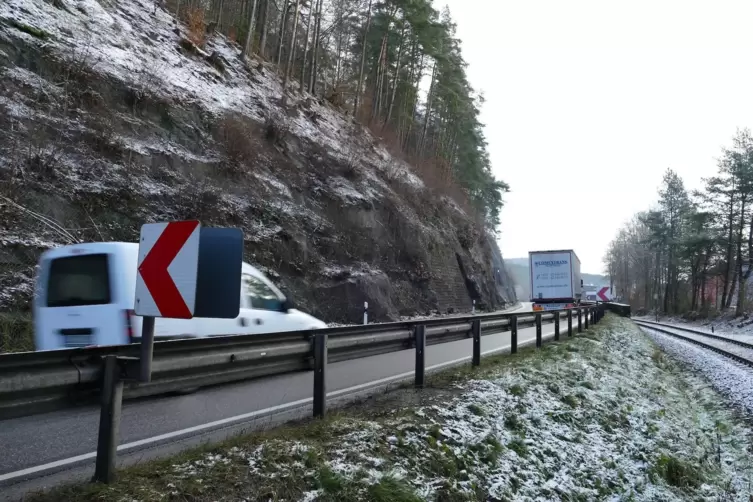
[0,0,423,187]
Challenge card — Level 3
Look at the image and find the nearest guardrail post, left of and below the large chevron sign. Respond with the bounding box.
[92,356,123,483]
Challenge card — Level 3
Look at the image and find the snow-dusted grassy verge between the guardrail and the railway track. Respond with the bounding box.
[23,316,753,502]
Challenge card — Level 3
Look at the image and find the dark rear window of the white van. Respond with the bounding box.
[47,254,110,307]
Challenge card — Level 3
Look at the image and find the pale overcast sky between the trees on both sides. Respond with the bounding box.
[435,0,753,273]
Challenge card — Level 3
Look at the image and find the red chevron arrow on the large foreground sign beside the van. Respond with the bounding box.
[139,221,199,319]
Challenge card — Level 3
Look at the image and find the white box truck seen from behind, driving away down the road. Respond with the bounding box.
[528,249,583,312]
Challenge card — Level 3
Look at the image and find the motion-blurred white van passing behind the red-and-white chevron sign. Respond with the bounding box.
[33,242,327,350]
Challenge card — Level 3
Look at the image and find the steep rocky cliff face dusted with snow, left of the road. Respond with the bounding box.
[0,0,514,322]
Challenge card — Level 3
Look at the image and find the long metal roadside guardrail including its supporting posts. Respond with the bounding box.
[0,304,604,482]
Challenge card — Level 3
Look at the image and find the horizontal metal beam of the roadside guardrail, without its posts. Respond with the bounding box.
[0,314,532,419]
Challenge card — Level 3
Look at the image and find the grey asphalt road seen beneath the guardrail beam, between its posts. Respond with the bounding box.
[0,305,575,494]
